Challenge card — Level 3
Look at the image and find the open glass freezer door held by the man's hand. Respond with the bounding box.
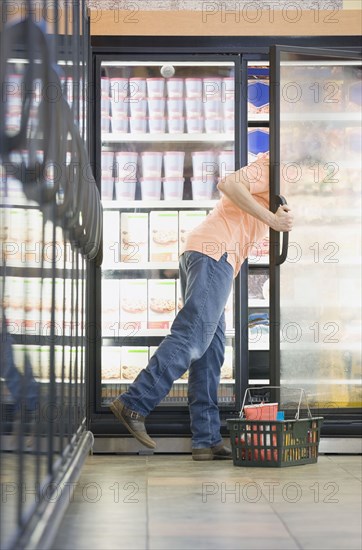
[270,47,361,410]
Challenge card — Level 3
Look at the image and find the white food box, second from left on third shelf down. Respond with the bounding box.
[120,212,148,264]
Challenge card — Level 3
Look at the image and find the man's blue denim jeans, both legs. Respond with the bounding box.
[119,251,233,448]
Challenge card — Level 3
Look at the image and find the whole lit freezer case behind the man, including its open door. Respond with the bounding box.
[90,46,361,450]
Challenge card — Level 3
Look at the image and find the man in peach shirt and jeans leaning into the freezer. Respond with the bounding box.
[110,155,293,460]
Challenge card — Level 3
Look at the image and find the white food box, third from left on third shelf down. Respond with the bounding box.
[150,210,178,262]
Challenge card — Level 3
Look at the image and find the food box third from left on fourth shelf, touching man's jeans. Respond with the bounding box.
[148,279,176,329]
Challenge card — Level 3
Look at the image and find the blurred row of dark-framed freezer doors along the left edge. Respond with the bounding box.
[0,0,102,549]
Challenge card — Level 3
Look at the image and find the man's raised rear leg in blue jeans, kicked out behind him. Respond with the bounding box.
[111,252,233,448]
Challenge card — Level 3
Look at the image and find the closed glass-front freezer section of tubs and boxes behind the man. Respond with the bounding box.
[96,56,240,422]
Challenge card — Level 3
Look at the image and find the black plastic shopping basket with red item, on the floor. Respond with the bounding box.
[226,386,323,468]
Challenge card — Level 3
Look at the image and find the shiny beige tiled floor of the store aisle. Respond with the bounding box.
[52,455,362,550]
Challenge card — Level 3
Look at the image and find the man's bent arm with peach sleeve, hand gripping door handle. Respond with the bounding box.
[217,156,293,231]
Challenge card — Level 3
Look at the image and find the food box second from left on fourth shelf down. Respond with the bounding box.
[119,279,147,336]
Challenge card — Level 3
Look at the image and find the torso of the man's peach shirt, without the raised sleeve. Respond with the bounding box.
[180,181,269,277]
